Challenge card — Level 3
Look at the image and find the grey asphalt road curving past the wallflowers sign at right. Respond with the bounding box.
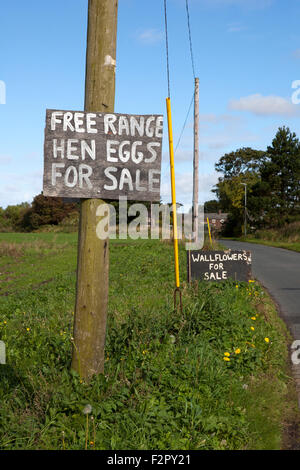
[220,240,300,340]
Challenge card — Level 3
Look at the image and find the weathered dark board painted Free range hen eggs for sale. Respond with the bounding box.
[43,110,163,201]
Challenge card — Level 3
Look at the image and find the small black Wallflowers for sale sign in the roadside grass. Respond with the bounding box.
[187,250,251,282]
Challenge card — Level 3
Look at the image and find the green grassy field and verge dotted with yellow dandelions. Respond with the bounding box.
[0,233,296,450]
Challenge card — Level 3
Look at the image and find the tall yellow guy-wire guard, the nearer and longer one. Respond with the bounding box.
[166,98,180,288]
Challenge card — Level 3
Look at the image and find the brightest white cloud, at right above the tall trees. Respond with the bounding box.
[228,93,296,116]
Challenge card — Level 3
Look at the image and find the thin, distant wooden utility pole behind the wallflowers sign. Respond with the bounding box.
[192,78,199,243]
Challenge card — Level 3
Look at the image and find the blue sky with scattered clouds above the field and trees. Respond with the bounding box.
[0,0,300,208]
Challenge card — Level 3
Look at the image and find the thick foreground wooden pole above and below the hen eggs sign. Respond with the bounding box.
[72,0,118,380]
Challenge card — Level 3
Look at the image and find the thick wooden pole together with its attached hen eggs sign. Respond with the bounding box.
[43,0,163,380]
